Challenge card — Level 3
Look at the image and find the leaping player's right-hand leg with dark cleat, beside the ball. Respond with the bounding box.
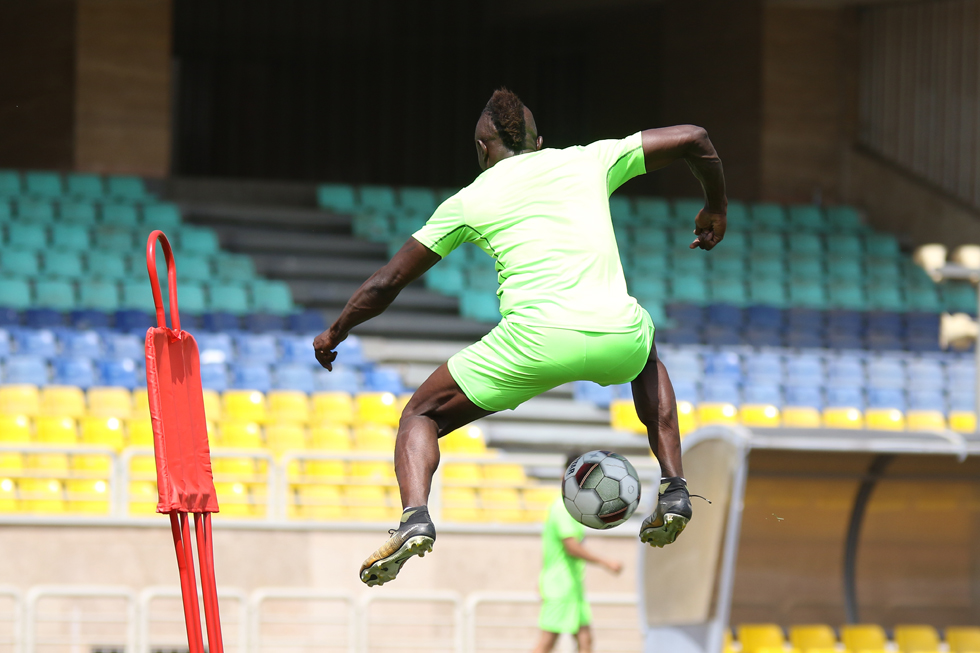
[632,346,693,547]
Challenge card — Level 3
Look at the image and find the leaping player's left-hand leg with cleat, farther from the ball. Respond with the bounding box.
[360,365,490,586]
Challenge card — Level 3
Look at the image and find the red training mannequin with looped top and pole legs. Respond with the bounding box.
[146,231,224,653]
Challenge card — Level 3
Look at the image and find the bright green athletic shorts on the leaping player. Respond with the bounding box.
[449,310,654,411]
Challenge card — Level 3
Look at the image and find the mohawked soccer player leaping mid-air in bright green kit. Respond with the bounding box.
[313,89,728,586]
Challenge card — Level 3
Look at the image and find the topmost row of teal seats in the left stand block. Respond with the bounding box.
[0,170,153,201]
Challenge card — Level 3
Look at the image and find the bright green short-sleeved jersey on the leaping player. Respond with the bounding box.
[414,133,646,333]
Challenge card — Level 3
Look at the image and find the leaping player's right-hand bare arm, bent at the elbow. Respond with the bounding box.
[642,125,728,249]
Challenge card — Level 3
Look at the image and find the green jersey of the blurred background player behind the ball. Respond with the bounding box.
[538,496,585,600]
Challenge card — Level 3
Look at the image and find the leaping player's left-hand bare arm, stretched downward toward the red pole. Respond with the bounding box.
[313,238,440,370]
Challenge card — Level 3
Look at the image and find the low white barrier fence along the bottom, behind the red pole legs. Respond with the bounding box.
[0,585,642,653]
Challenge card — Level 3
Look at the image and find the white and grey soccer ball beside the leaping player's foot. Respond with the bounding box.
[561,451,640,530]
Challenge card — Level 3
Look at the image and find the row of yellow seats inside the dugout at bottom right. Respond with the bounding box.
[724,624,980,653]
